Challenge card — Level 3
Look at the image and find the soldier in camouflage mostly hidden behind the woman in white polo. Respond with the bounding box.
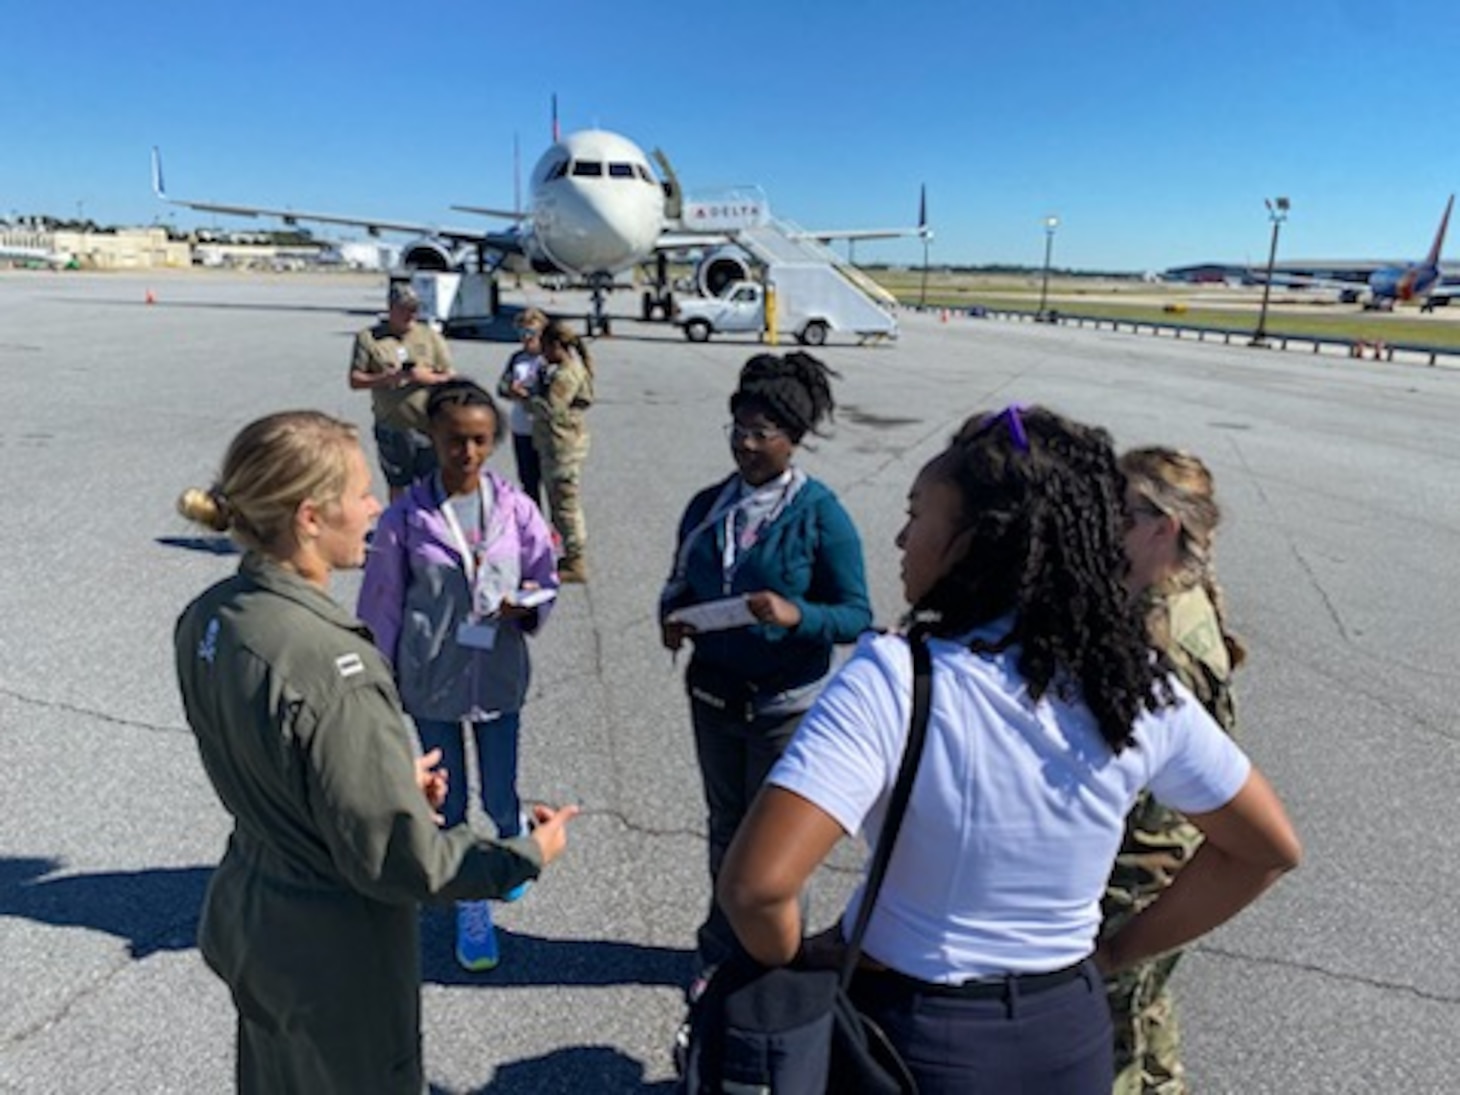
[1101,448,1244,1095]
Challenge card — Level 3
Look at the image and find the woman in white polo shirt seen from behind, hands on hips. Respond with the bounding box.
[718,407,1299,1095]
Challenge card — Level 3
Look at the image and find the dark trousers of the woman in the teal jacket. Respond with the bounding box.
[689,699,806,967]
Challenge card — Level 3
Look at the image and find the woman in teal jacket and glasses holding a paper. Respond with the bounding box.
[660,352,872,967]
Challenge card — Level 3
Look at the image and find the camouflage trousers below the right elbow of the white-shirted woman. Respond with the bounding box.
[1105,950,1187,1095]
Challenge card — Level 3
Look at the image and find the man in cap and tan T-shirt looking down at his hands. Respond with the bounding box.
[349,282,453,502]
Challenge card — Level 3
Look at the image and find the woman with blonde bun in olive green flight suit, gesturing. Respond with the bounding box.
[175,410,577,1095]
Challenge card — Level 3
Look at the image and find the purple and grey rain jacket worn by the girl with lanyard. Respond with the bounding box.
[356,470,558,721]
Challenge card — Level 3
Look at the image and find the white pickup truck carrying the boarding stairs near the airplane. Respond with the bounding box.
[675,263,898,346]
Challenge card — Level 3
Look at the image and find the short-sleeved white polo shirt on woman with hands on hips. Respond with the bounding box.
[769,635,1251,983]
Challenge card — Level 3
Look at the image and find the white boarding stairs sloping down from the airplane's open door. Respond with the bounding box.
[734,218,898,339]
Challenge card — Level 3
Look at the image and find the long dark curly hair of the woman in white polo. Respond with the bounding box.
[913,406,1172,752]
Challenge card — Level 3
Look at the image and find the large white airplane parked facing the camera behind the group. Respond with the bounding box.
[152,130,927,334]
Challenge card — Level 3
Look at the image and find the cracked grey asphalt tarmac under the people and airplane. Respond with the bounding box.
[0,273,1460,1095]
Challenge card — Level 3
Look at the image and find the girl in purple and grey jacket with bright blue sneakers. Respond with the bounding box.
[359,380,558,971]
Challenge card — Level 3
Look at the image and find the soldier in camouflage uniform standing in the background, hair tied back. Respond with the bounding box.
[529,320,593,583]
